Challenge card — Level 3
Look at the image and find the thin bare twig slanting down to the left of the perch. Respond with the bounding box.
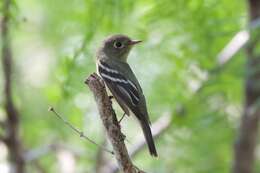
[48,107,114,155]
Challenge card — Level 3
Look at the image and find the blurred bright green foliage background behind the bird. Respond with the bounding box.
[0,0,260,173]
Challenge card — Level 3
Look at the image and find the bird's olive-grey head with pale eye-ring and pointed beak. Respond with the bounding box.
[98,34,141,62]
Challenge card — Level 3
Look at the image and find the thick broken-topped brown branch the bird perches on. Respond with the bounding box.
[85,73,144,173]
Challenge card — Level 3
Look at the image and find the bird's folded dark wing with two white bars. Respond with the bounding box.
[98,61,140,109]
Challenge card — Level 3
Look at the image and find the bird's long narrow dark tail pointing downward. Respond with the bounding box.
[140,121,158,157]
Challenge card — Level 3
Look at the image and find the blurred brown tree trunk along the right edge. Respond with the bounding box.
[233,0,260,173]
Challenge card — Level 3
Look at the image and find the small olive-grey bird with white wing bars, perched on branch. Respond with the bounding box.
[96,34,158,157]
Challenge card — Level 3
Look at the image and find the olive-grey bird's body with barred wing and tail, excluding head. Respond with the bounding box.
[98,61,158,156]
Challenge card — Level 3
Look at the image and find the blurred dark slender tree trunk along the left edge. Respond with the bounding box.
[1,0,24,173]
